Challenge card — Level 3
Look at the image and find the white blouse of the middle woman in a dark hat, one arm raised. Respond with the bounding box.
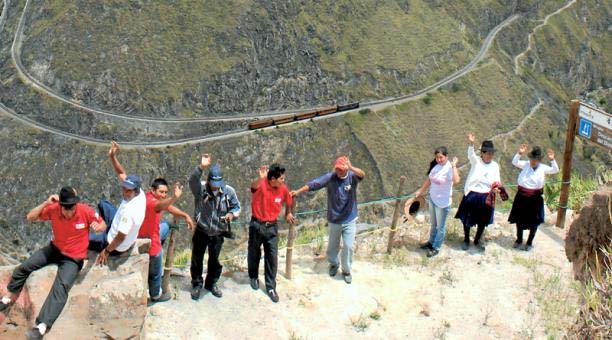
[463,145,501,195]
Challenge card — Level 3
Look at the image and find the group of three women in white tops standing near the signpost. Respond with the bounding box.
[414,133,559,257]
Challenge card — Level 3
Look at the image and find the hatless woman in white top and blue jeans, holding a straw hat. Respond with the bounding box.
[416,146,461,257]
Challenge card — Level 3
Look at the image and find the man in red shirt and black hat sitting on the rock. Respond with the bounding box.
[0,187,106,339]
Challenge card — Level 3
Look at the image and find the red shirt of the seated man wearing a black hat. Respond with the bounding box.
[39,203,103,259]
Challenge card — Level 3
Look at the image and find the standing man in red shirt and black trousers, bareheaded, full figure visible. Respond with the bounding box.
[248,164,295,302]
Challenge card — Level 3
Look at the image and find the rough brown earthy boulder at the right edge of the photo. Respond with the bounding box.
[565,186,612,281]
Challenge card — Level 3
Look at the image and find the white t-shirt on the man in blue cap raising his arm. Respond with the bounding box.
[106,189,147,251]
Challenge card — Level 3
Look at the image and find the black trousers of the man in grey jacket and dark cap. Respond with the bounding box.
[190,228,224,290]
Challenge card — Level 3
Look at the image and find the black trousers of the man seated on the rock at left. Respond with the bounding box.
[7,243,83,328]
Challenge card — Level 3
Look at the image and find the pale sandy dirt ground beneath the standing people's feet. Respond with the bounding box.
[145,216,572,339]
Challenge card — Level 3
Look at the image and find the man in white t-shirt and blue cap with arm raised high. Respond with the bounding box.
[96,142,146,265]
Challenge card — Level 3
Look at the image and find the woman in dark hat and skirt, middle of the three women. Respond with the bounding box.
[455,133,501,251]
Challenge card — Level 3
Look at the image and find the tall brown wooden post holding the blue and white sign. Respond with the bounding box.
[557,100,580,228]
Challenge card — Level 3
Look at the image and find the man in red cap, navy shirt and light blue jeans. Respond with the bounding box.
[291,156,365,283]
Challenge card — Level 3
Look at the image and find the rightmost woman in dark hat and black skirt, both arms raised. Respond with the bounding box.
[508,144,559,251]
